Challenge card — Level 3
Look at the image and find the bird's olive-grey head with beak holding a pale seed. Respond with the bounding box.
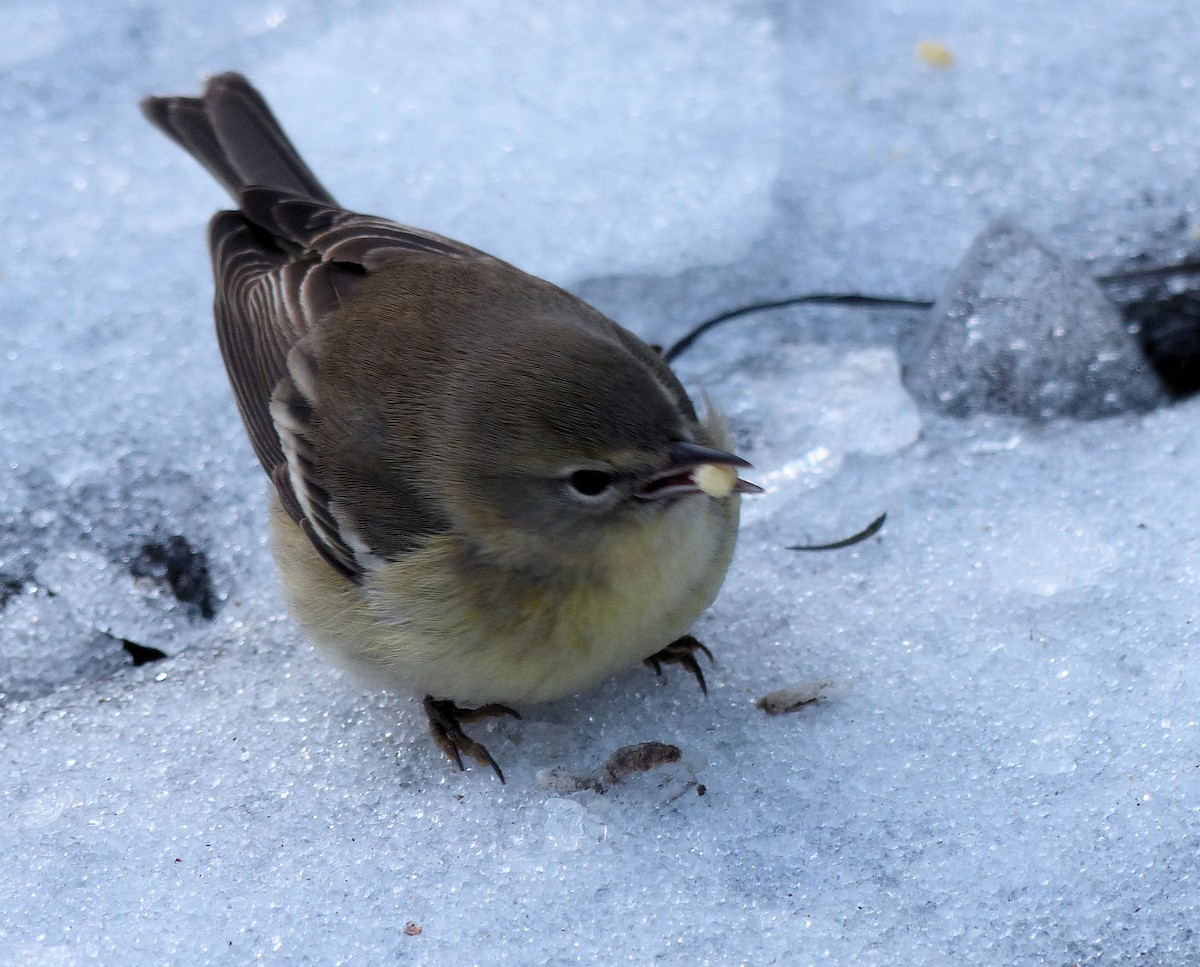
[446,324,758,575]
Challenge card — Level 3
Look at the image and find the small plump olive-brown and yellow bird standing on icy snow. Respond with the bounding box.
[142,73,760,782]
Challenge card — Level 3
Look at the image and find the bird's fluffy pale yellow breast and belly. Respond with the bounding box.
[271,494,738,704]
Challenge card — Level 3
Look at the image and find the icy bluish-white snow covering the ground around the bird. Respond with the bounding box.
[0,0,1200,967]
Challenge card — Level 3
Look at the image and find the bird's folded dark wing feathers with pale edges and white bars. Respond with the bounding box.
[209,186,490,579]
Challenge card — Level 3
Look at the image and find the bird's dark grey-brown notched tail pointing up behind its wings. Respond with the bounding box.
[142,72,337,205]
